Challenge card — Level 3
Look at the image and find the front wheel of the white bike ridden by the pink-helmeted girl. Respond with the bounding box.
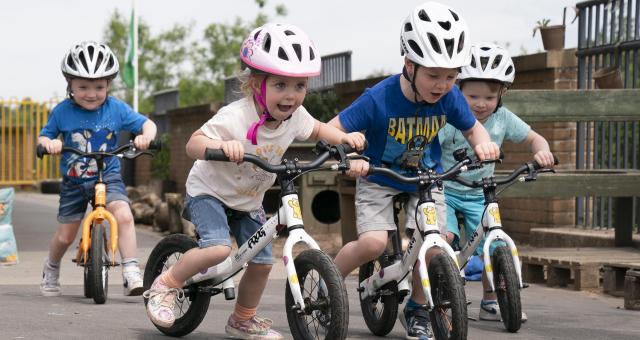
[285,249,349,339]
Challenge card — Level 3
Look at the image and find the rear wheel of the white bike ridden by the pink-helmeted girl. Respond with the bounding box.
[144,234,211,337]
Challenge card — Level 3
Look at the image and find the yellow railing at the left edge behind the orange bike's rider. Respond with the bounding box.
[0,99,60,185]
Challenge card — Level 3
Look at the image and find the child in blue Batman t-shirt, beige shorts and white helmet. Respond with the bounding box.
[329,2,499,339]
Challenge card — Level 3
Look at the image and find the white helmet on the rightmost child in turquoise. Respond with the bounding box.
[458,43,516,84]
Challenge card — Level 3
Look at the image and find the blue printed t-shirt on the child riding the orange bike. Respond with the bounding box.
[40,96,147,183]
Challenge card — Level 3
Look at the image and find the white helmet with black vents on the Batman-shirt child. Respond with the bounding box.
[400,2,471,68]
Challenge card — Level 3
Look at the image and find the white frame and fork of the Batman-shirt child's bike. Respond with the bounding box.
[360,188,460,309]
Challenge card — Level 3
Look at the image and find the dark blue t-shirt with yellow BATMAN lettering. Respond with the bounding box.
[339,75,476,192]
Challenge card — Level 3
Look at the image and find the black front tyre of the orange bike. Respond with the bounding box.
[85,224,109,304]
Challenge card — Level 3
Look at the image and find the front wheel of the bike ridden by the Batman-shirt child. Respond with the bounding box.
[427,252,468,340]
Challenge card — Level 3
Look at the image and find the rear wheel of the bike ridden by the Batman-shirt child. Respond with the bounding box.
[358,255,398,336]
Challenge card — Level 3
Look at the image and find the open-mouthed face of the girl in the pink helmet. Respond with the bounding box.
[266,75,307,120]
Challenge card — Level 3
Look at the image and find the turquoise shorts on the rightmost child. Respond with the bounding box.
[445,189,505,255]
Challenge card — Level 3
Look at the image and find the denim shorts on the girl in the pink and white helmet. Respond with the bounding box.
[183,195,273,264]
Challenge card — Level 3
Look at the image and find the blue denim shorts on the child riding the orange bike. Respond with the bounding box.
[58,173,129,223]
